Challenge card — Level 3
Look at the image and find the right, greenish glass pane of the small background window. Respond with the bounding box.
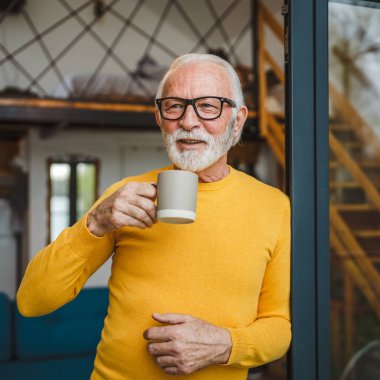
[76,163,96,219]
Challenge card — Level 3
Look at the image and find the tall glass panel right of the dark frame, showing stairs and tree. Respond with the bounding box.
[329,2,380,380]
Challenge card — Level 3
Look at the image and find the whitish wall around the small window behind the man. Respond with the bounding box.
[29,130,169,286]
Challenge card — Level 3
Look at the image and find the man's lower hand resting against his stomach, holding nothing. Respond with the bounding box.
[144,314,232,375]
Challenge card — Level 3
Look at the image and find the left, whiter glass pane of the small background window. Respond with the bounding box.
[50,163,70,241]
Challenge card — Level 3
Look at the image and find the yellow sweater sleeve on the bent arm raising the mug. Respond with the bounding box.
[17,182,121,317]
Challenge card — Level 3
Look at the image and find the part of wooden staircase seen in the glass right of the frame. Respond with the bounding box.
[329,90,380,317]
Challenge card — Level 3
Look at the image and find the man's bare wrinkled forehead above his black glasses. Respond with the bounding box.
[162,63,233,98]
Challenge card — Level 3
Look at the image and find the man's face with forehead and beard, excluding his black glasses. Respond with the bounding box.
[157,62,239,171]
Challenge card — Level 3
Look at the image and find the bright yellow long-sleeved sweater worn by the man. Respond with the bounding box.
[17,167,291,380]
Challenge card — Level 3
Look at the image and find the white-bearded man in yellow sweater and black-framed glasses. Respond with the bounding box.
[17,54,291,380]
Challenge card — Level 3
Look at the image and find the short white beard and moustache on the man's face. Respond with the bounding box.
[162,118,235,172]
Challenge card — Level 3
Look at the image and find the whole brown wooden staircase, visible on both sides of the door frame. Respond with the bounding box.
[258,0,380,324]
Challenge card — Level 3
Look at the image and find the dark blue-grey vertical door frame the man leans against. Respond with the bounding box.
[283,0,330,380]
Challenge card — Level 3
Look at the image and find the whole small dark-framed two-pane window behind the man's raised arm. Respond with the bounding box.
[48,155,99,242]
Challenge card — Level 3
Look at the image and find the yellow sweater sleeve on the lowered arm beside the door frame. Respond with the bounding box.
[227,202,291,367]
